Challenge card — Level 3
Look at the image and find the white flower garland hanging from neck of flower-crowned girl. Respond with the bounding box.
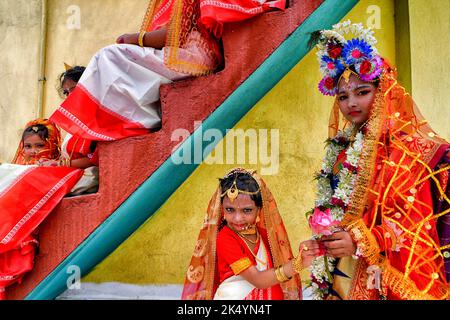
[310,128,364,300]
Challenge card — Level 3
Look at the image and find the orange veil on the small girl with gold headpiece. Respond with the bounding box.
[182,169,302,300]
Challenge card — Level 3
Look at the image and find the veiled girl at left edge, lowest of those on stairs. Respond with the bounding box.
[0,119,82,300]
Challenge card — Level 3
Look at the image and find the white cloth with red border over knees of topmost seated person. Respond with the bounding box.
[50,44,189,141]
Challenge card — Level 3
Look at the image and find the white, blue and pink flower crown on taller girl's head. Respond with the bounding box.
[317,20,383,96]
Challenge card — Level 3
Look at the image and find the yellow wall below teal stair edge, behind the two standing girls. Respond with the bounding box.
[83,0,395,284]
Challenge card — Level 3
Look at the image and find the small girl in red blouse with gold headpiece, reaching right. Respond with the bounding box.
[182,168,318,300]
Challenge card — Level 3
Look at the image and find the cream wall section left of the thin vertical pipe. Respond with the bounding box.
[0,0,41,162]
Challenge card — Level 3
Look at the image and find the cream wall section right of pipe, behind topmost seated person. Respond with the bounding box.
[44,0,148,116]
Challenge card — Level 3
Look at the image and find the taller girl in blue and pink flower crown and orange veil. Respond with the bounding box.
[307,21,450,299]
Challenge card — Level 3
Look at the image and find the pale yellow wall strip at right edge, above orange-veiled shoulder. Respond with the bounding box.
[409,0,450,141]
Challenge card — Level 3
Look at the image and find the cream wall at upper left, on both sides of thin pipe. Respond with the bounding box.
[0,0,148,162]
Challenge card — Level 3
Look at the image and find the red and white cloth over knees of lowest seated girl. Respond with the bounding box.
[0,164,83,254]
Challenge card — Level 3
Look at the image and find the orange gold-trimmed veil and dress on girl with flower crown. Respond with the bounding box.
[329,61,450,299]
